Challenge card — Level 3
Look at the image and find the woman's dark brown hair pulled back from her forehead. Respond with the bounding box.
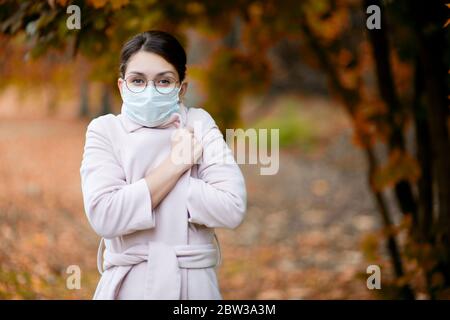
[120,30,186,82]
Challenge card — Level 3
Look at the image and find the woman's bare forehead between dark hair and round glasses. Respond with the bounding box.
[126,51,177,77]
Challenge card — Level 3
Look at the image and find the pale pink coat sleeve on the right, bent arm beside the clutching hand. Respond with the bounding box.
[187,110,247,229]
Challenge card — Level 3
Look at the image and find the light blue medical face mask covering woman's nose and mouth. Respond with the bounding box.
[121,81,181,127]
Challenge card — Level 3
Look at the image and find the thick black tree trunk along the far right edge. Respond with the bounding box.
[405,1,450,287]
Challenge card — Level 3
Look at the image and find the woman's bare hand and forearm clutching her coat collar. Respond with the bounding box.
[145,128,203,209]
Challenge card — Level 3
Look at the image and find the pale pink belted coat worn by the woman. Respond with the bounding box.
[80,104,247,299]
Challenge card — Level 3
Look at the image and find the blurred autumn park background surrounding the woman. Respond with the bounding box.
[0,0,450,299]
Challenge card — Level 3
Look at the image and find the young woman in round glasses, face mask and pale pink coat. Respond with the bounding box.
[80,31,247,300]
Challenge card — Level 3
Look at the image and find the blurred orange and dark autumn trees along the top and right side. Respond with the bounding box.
[0,0,450,299]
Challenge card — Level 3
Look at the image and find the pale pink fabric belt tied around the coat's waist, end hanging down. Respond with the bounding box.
[97,234,222,300]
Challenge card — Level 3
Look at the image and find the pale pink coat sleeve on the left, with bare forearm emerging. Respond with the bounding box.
[80,117,155,238]
